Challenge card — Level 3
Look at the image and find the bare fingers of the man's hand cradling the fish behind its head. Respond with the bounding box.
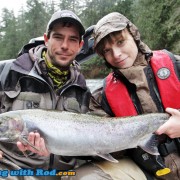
[17,132,50,156]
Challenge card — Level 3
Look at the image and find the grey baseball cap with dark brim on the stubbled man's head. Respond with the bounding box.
[46,10,85,35]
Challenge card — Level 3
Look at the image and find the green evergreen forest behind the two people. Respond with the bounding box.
[0,0,180,78]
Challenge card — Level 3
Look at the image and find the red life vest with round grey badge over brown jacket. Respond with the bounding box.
[105,51,180,117]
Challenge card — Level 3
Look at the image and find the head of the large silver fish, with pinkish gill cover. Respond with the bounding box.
[0,113,24,142]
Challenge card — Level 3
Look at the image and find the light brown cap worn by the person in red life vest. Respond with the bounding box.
[94,12,129,48]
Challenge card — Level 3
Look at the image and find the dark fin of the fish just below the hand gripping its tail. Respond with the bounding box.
[139,134,159,155]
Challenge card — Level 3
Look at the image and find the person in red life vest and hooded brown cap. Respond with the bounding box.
[87,12,180,179]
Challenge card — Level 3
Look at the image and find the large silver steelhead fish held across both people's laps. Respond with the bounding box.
[0,109,170,162]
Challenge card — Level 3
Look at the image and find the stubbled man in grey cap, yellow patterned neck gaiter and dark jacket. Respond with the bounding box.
[0,10,90,179]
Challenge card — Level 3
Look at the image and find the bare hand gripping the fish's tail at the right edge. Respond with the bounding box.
[156,108,180,138]
